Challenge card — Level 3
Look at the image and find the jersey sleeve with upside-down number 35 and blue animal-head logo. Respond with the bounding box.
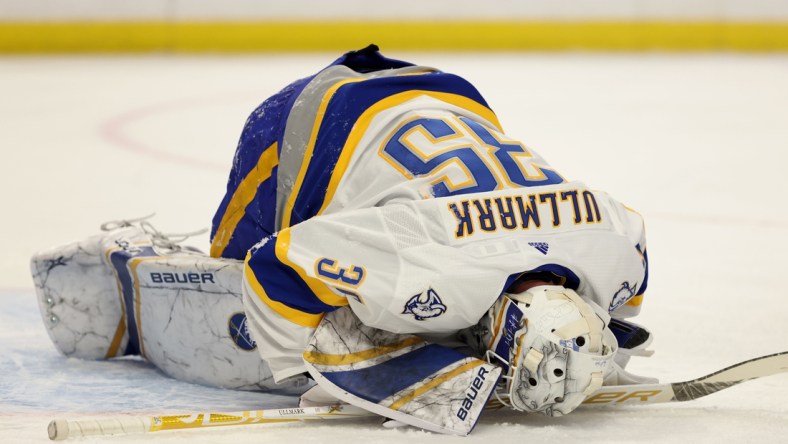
[244,201,521,380]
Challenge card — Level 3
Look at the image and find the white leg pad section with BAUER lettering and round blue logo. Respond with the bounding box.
[134,253,288,390]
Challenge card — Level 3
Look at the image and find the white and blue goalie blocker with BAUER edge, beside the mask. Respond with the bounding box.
[304,307,501,435]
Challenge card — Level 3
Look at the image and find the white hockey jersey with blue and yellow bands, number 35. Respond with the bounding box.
[212,47,647,380]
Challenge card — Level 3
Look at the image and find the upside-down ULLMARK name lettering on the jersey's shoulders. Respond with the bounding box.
[448,190,602,239]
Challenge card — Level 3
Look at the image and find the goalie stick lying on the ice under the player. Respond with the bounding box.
[48,351,788,440]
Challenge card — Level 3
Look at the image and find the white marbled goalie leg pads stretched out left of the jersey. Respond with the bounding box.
[31,223,307,390]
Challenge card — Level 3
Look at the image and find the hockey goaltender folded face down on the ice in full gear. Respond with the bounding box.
[32,46,786,438]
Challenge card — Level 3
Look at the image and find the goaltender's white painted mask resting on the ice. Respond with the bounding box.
[486,285,618,416]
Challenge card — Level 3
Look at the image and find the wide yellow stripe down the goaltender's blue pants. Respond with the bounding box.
[211,142,279,257]
